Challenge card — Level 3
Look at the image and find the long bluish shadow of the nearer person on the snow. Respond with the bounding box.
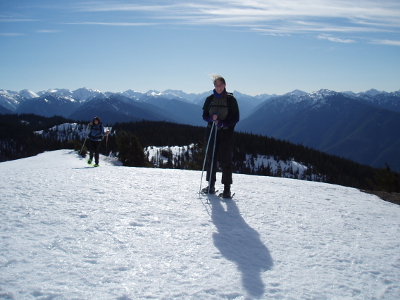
[210,197,273,297]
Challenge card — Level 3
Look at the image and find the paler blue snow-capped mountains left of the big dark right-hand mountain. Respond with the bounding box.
[0,88,276,125]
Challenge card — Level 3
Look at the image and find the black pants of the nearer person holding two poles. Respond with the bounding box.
[206,126,233,186]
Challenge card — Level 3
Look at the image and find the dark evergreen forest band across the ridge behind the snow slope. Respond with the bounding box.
[0,114,399,189]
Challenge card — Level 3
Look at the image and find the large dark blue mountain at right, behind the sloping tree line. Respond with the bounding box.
[237,90,400,171]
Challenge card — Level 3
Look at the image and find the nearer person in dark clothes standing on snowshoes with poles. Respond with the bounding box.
[202,74,239,198]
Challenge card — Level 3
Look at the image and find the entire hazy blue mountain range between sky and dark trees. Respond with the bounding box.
[0,88,400,171]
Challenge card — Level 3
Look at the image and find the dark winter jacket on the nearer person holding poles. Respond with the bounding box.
[203,90,240,130]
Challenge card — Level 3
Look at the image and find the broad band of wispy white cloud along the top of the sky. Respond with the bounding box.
[50,0,400,45]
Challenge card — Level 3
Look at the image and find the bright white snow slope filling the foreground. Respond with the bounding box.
[0,150,400,300]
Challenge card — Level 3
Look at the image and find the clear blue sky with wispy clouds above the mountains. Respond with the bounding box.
[0,0,400,95]
